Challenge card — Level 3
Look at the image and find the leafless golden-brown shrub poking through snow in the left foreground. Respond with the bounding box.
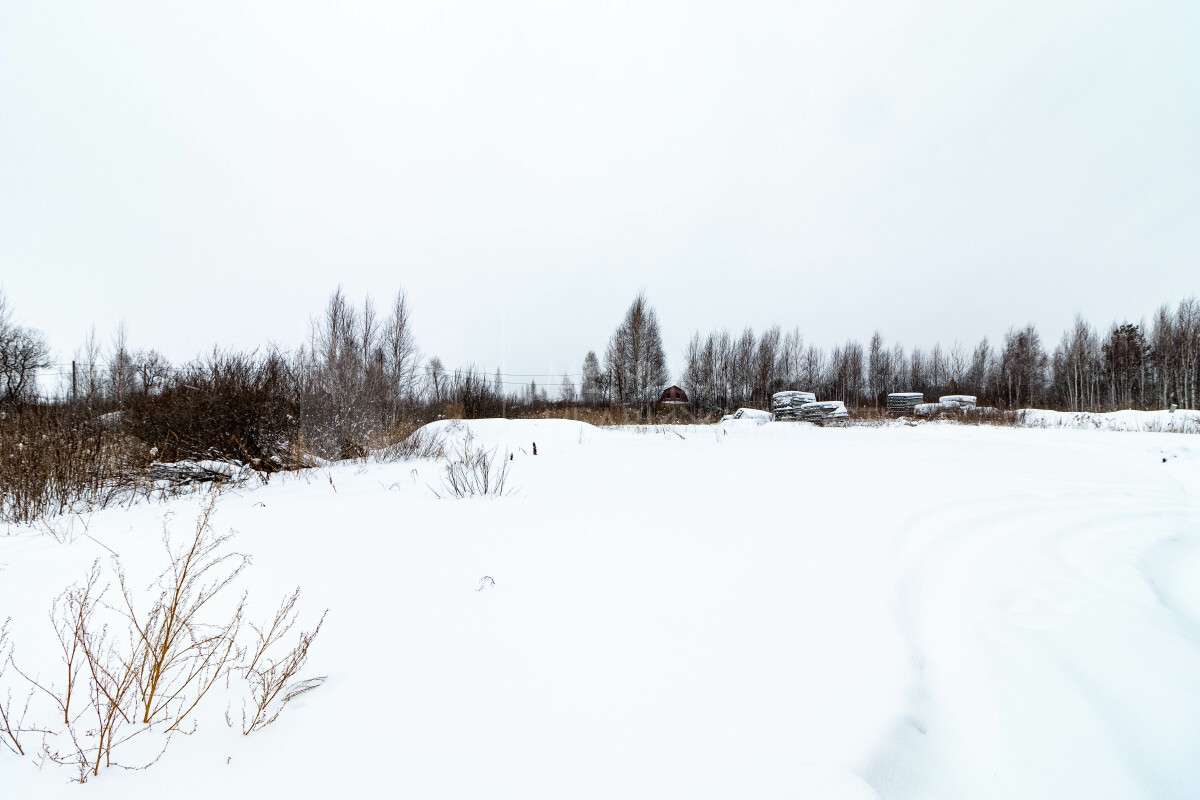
[9,497,325,783]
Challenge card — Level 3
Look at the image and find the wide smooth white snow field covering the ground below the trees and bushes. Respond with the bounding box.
[0,421,1200,800]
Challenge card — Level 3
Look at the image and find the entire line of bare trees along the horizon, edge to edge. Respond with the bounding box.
[0,288,1200,424]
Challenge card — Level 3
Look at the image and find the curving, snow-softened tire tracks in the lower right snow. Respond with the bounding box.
[864,487,1200,798]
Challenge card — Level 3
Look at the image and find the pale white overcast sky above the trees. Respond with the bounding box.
[0,0,1200,388]
